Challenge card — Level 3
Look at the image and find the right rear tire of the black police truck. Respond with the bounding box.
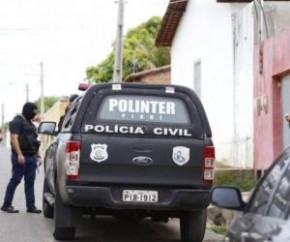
[180,209,207,242]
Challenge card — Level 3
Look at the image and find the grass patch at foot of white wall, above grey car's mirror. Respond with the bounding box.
[213,169,257,191]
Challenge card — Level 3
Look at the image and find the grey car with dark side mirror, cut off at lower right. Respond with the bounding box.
[211,147,290,242]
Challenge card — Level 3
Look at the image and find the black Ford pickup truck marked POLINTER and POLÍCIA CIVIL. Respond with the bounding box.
[39,83,215,242]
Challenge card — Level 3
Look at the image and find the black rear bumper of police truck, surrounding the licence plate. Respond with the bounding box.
[65,186,210,210]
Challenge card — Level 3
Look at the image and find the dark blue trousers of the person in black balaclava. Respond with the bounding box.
[4,152,37,208]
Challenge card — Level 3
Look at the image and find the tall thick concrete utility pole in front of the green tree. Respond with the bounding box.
[113,0,124,82]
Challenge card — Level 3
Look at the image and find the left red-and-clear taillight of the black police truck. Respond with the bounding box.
[65,141,81,179]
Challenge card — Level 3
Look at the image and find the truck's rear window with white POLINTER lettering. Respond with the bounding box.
[97,95,190,125]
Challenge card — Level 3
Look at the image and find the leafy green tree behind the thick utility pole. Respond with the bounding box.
[86,17,170,83]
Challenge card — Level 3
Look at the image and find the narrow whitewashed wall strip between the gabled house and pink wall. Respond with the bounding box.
[231,3,255,167]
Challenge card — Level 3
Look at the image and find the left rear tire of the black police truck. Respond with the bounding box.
[53,184,76,240]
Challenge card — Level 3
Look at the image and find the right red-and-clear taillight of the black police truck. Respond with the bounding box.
[203,146,215,184]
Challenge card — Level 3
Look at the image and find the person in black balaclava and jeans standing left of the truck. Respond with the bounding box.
[1,102,41,213]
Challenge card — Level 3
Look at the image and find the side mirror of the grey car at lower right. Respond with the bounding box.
[210,186,246,210]
